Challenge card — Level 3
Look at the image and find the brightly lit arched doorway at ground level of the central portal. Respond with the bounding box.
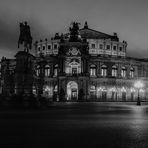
[67,81,78,101]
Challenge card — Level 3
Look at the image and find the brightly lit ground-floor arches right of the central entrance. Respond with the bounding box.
[89,85,145,101]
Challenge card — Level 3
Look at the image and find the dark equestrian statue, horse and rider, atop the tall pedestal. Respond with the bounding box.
[18,22,32,52]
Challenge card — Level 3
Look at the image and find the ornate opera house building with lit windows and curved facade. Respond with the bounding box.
[1,22,148,101]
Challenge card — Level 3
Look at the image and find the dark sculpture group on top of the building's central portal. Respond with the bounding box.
[69,22,80,42]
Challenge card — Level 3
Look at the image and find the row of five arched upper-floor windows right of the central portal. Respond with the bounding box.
[90,65,134,78]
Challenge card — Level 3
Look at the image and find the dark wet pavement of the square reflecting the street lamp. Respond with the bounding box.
[0,102,148,148]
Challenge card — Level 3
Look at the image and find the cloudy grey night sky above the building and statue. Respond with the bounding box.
[0,0,148,58]
